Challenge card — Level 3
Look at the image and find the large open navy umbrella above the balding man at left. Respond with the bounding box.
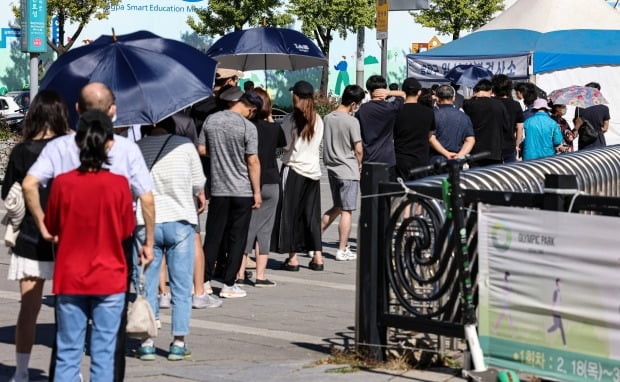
[40,31,217,127]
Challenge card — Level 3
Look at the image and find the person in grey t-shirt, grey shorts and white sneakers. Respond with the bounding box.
[321,85,364,261]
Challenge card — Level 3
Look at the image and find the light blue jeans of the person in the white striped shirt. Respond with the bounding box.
[133,221,196,336]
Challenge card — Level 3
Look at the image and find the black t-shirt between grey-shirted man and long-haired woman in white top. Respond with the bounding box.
[256,120,286,185]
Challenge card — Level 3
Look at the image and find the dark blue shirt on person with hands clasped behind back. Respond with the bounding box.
[434,105,474,154]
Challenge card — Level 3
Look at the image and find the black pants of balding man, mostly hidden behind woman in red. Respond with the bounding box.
[49,238,133,382]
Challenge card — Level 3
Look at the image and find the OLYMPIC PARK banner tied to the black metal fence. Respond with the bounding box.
[478,204,620,382]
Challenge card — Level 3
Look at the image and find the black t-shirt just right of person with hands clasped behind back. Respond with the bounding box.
[463,97,510,161]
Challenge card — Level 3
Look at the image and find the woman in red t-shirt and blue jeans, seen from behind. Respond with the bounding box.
[45,110,135,381]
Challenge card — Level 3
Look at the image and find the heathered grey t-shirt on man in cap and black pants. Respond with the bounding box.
[198,110,258,197]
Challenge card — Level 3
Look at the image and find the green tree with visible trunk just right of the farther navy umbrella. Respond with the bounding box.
[289,0,375,95]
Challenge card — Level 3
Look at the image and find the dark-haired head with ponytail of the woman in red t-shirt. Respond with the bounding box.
[75,110,114,172]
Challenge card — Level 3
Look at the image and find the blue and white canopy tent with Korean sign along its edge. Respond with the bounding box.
[407,0,620,143]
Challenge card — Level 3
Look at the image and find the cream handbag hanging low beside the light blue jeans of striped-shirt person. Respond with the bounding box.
[125,264,157,339]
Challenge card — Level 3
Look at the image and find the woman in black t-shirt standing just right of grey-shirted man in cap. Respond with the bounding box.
[237,88,286,288]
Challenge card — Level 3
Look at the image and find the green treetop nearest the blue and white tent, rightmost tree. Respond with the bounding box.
[410,0,504,40]
